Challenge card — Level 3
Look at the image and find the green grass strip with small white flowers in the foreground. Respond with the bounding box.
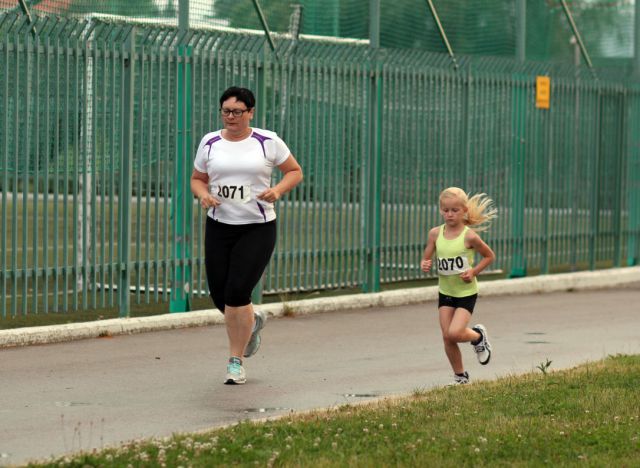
[31,355,640,467]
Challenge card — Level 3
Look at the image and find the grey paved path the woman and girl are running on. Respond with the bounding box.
[0,283,640,465]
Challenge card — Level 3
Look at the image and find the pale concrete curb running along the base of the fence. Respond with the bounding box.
[0,266,640,348]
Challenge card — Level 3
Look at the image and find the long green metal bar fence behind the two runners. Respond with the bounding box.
[0,14,640,317]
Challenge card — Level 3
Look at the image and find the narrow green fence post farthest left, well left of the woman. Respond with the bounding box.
[118,27,136,317]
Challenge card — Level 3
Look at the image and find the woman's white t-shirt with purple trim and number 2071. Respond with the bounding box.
[193,128,291,224]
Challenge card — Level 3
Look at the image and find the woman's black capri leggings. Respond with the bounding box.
[204,216,276,313]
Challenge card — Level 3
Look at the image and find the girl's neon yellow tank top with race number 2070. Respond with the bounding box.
[436,224,478,297]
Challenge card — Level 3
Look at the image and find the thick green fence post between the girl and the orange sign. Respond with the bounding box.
[509,75,529,278]
